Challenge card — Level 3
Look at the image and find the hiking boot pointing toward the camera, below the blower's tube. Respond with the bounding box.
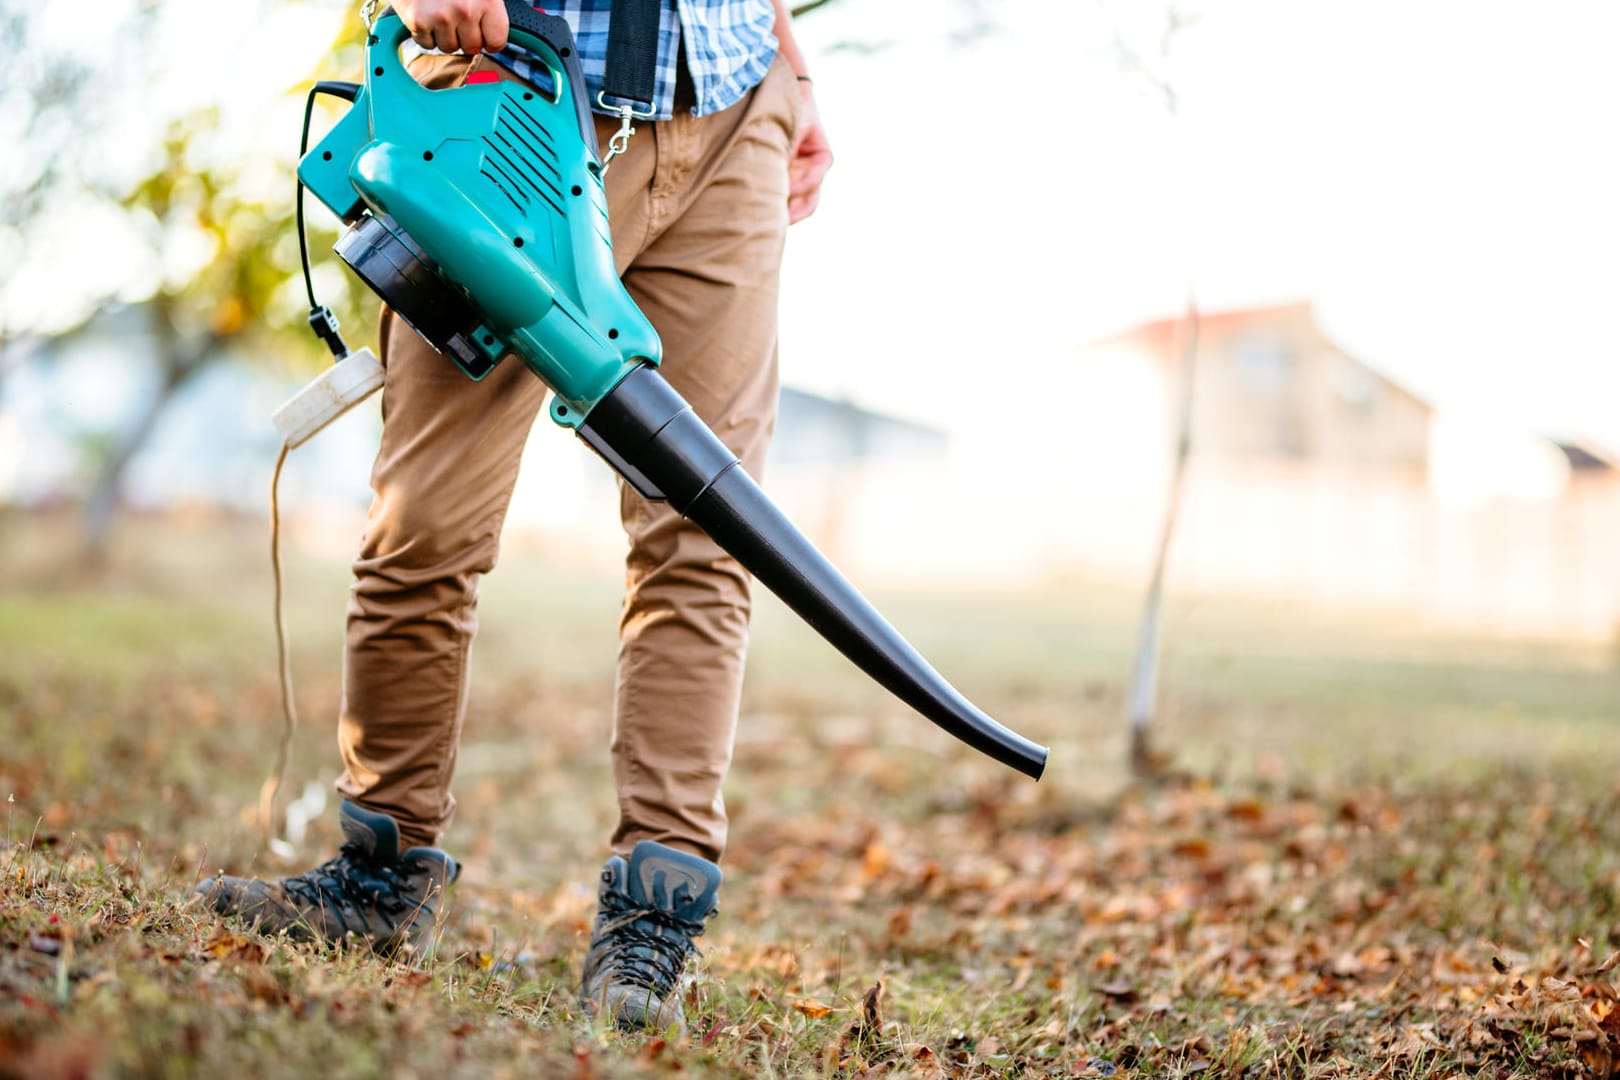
[580,840,721,1035]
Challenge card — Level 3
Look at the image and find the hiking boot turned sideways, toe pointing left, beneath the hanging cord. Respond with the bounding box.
[196,798,462,950]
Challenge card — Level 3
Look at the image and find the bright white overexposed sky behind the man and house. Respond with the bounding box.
[15,0,1620,447]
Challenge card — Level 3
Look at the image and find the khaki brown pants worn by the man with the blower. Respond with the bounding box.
[337,57,799,860]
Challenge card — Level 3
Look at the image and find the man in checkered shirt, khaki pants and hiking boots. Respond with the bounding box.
[199,0,831,1030]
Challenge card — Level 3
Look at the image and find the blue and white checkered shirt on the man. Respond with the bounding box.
[496,0,776,120]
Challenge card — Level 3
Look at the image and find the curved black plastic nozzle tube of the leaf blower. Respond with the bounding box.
[580,364,1047,780]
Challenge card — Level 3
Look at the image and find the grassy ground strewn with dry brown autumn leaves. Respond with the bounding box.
[0,515,1620,1077]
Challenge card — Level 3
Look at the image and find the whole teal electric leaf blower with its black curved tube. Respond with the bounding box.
[298,0,1047,779]
